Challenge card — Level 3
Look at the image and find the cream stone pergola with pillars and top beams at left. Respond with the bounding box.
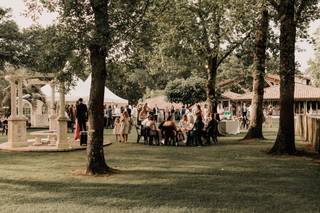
[5,70,70,149]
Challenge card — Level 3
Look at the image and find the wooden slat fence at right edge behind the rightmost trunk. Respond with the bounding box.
[295,115,320,153]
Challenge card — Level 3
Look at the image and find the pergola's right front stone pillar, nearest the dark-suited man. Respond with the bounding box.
[56,83,70,149]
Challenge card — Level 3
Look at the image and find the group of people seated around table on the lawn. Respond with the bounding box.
[137,104,218,146]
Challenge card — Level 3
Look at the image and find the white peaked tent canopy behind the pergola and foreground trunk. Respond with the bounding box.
[41,75,128,105]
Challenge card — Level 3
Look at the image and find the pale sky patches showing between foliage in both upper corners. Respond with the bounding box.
[0,0,320,71]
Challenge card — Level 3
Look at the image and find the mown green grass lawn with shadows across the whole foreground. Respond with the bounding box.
[0,129,320,213]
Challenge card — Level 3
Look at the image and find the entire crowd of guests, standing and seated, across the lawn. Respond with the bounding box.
[61,99,273,146]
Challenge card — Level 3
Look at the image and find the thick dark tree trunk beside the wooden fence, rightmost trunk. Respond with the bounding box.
[270,0,296,154]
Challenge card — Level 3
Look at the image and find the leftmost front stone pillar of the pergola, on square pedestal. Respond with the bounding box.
[6,76,28,148]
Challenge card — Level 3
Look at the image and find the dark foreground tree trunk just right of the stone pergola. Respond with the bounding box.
[86,0,111,174]
